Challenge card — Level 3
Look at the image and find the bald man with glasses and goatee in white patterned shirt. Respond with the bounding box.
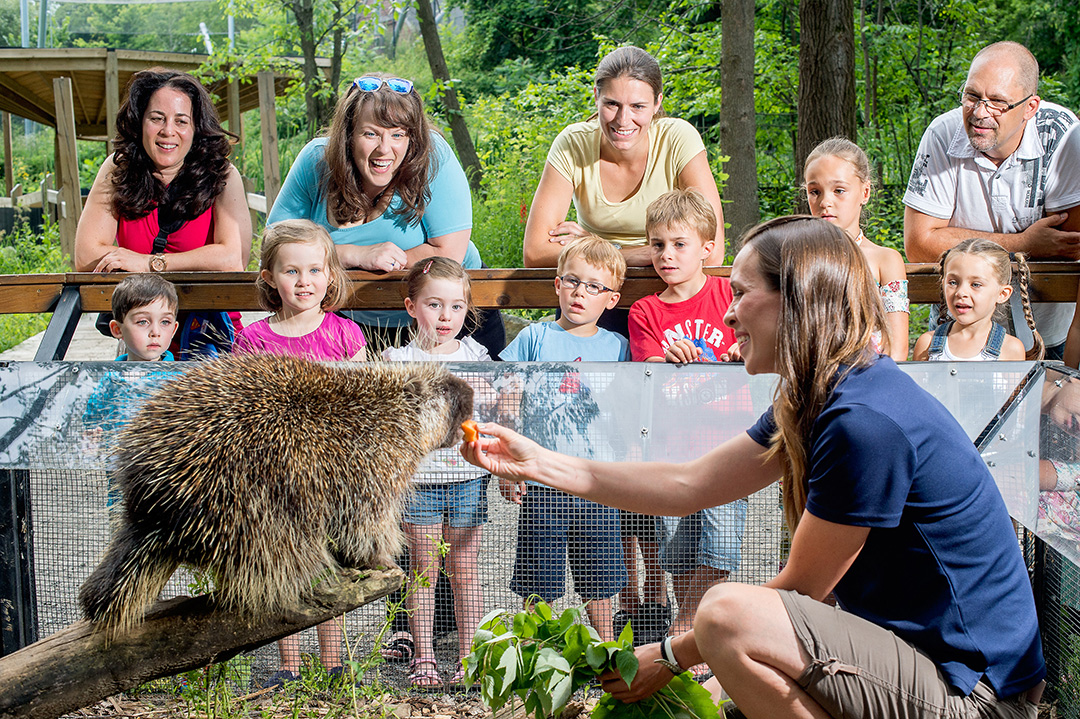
[904,42,1080,360]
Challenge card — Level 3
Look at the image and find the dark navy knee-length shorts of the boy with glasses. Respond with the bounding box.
[510,484,626,601]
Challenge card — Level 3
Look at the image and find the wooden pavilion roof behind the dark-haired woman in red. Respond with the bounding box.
[0,48,329,140]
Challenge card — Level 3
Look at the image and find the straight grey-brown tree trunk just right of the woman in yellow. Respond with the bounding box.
[720,0,760,246]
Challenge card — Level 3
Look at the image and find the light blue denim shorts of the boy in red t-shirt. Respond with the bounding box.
[660,499,746,574]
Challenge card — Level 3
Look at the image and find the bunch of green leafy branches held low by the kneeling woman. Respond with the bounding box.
[464,601,719,719]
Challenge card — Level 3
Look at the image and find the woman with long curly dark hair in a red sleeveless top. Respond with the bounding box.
[75,68,252,272]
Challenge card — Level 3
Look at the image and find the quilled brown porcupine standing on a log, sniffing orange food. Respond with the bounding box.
[79,355,473,635]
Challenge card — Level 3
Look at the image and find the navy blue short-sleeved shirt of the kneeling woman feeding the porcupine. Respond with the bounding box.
[748,356,1045,696]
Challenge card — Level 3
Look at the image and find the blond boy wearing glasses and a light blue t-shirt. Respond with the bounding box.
[499,235,630,641]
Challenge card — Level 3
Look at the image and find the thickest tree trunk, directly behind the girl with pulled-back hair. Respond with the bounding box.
[795,0,856,180]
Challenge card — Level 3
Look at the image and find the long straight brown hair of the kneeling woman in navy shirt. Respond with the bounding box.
[742,215,886,532]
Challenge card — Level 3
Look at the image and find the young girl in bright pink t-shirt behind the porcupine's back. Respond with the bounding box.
[233,220,367,687]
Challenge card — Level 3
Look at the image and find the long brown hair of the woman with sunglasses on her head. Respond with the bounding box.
[323,72,435,225]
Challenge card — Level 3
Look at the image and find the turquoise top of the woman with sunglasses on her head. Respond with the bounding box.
[267,133,481,326]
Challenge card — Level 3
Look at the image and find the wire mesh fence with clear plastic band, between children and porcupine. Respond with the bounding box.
[0,363,1080,703]
